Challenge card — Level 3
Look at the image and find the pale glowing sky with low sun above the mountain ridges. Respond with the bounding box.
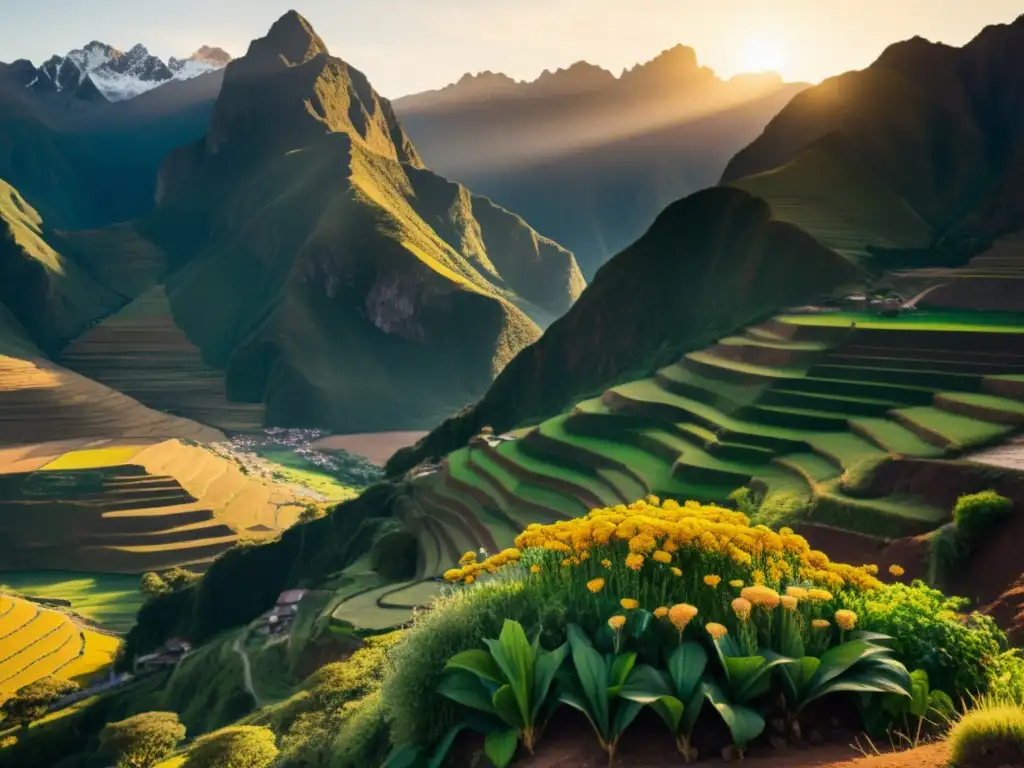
[0,0,1024,97]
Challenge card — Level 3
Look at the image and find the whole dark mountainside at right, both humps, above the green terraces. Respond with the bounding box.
[389,9,1024,472]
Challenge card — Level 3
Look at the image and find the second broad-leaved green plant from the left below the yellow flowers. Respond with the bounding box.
[559,624,664,760]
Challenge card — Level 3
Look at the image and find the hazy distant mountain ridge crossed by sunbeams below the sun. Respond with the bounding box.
[395,46,805,278]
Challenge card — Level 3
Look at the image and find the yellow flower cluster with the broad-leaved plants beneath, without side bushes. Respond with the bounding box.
[428,497,925,765]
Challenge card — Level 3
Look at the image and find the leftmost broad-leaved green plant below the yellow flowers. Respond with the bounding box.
[437,620,567,768]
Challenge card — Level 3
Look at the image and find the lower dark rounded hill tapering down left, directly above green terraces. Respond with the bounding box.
[388,187,858,473]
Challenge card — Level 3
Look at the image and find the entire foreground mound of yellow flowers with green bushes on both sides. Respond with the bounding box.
[382,498,1024,765]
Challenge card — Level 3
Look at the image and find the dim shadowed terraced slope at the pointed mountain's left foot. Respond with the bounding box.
[60,286,263,432]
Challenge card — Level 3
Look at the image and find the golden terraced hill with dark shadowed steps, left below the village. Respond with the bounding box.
[0,440,302,573]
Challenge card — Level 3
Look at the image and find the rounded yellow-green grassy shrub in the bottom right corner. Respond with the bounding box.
[949,698,1024,768]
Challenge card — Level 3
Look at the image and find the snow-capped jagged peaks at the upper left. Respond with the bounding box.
[26,40,231,101]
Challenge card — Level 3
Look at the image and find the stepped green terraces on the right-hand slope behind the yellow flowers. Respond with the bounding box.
[335,311,1024,627]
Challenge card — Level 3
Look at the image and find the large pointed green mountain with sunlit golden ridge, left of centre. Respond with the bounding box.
[56,12,584,431]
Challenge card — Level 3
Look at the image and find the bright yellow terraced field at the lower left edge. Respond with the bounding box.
[0,594,120,701]
